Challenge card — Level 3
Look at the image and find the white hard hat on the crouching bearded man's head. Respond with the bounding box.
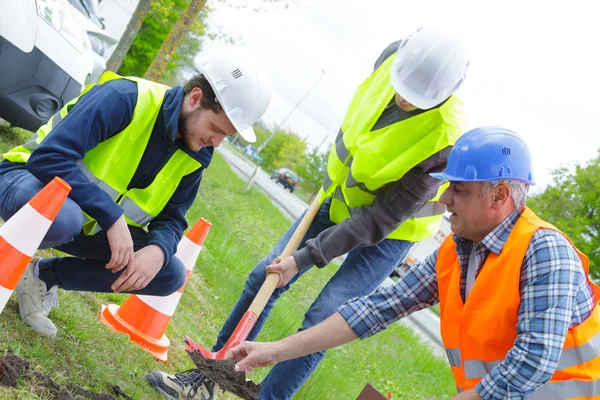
[196,46,271,143]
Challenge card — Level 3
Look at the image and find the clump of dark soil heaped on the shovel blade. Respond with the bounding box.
[188,350,260,400]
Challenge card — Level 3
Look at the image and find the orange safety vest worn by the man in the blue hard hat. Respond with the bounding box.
[436,208,600,400]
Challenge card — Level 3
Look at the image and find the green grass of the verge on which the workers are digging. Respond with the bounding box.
[0,126,454,400]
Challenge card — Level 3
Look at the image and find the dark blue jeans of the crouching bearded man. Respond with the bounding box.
[0,169,186,296]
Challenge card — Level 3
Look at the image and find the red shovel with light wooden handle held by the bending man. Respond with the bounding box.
[185,191,321,360]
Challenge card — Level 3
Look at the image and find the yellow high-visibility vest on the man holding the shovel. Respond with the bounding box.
[321,52,465,242]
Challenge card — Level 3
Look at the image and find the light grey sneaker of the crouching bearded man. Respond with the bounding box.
[16,258,58,337]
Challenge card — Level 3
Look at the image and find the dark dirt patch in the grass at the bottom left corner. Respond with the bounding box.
[0,349,132,400]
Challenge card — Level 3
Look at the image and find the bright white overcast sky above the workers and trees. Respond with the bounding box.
[204,0,600,189]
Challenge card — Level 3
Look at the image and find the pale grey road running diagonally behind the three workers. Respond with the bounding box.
[216,145,446,359]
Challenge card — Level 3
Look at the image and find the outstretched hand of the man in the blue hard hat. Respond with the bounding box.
[225,342,279,374]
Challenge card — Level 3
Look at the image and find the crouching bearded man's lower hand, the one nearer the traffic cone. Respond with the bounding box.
[110,244,165,293]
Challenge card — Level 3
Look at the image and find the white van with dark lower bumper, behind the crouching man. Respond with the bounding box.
[0,0,92,131]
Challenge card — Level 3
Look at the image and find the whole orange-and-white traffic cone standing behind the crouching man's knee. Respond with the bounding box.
[100,218,212,361]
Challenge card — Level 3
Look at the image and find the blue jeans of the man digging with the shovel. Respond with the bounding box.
[212,201,412,400]
